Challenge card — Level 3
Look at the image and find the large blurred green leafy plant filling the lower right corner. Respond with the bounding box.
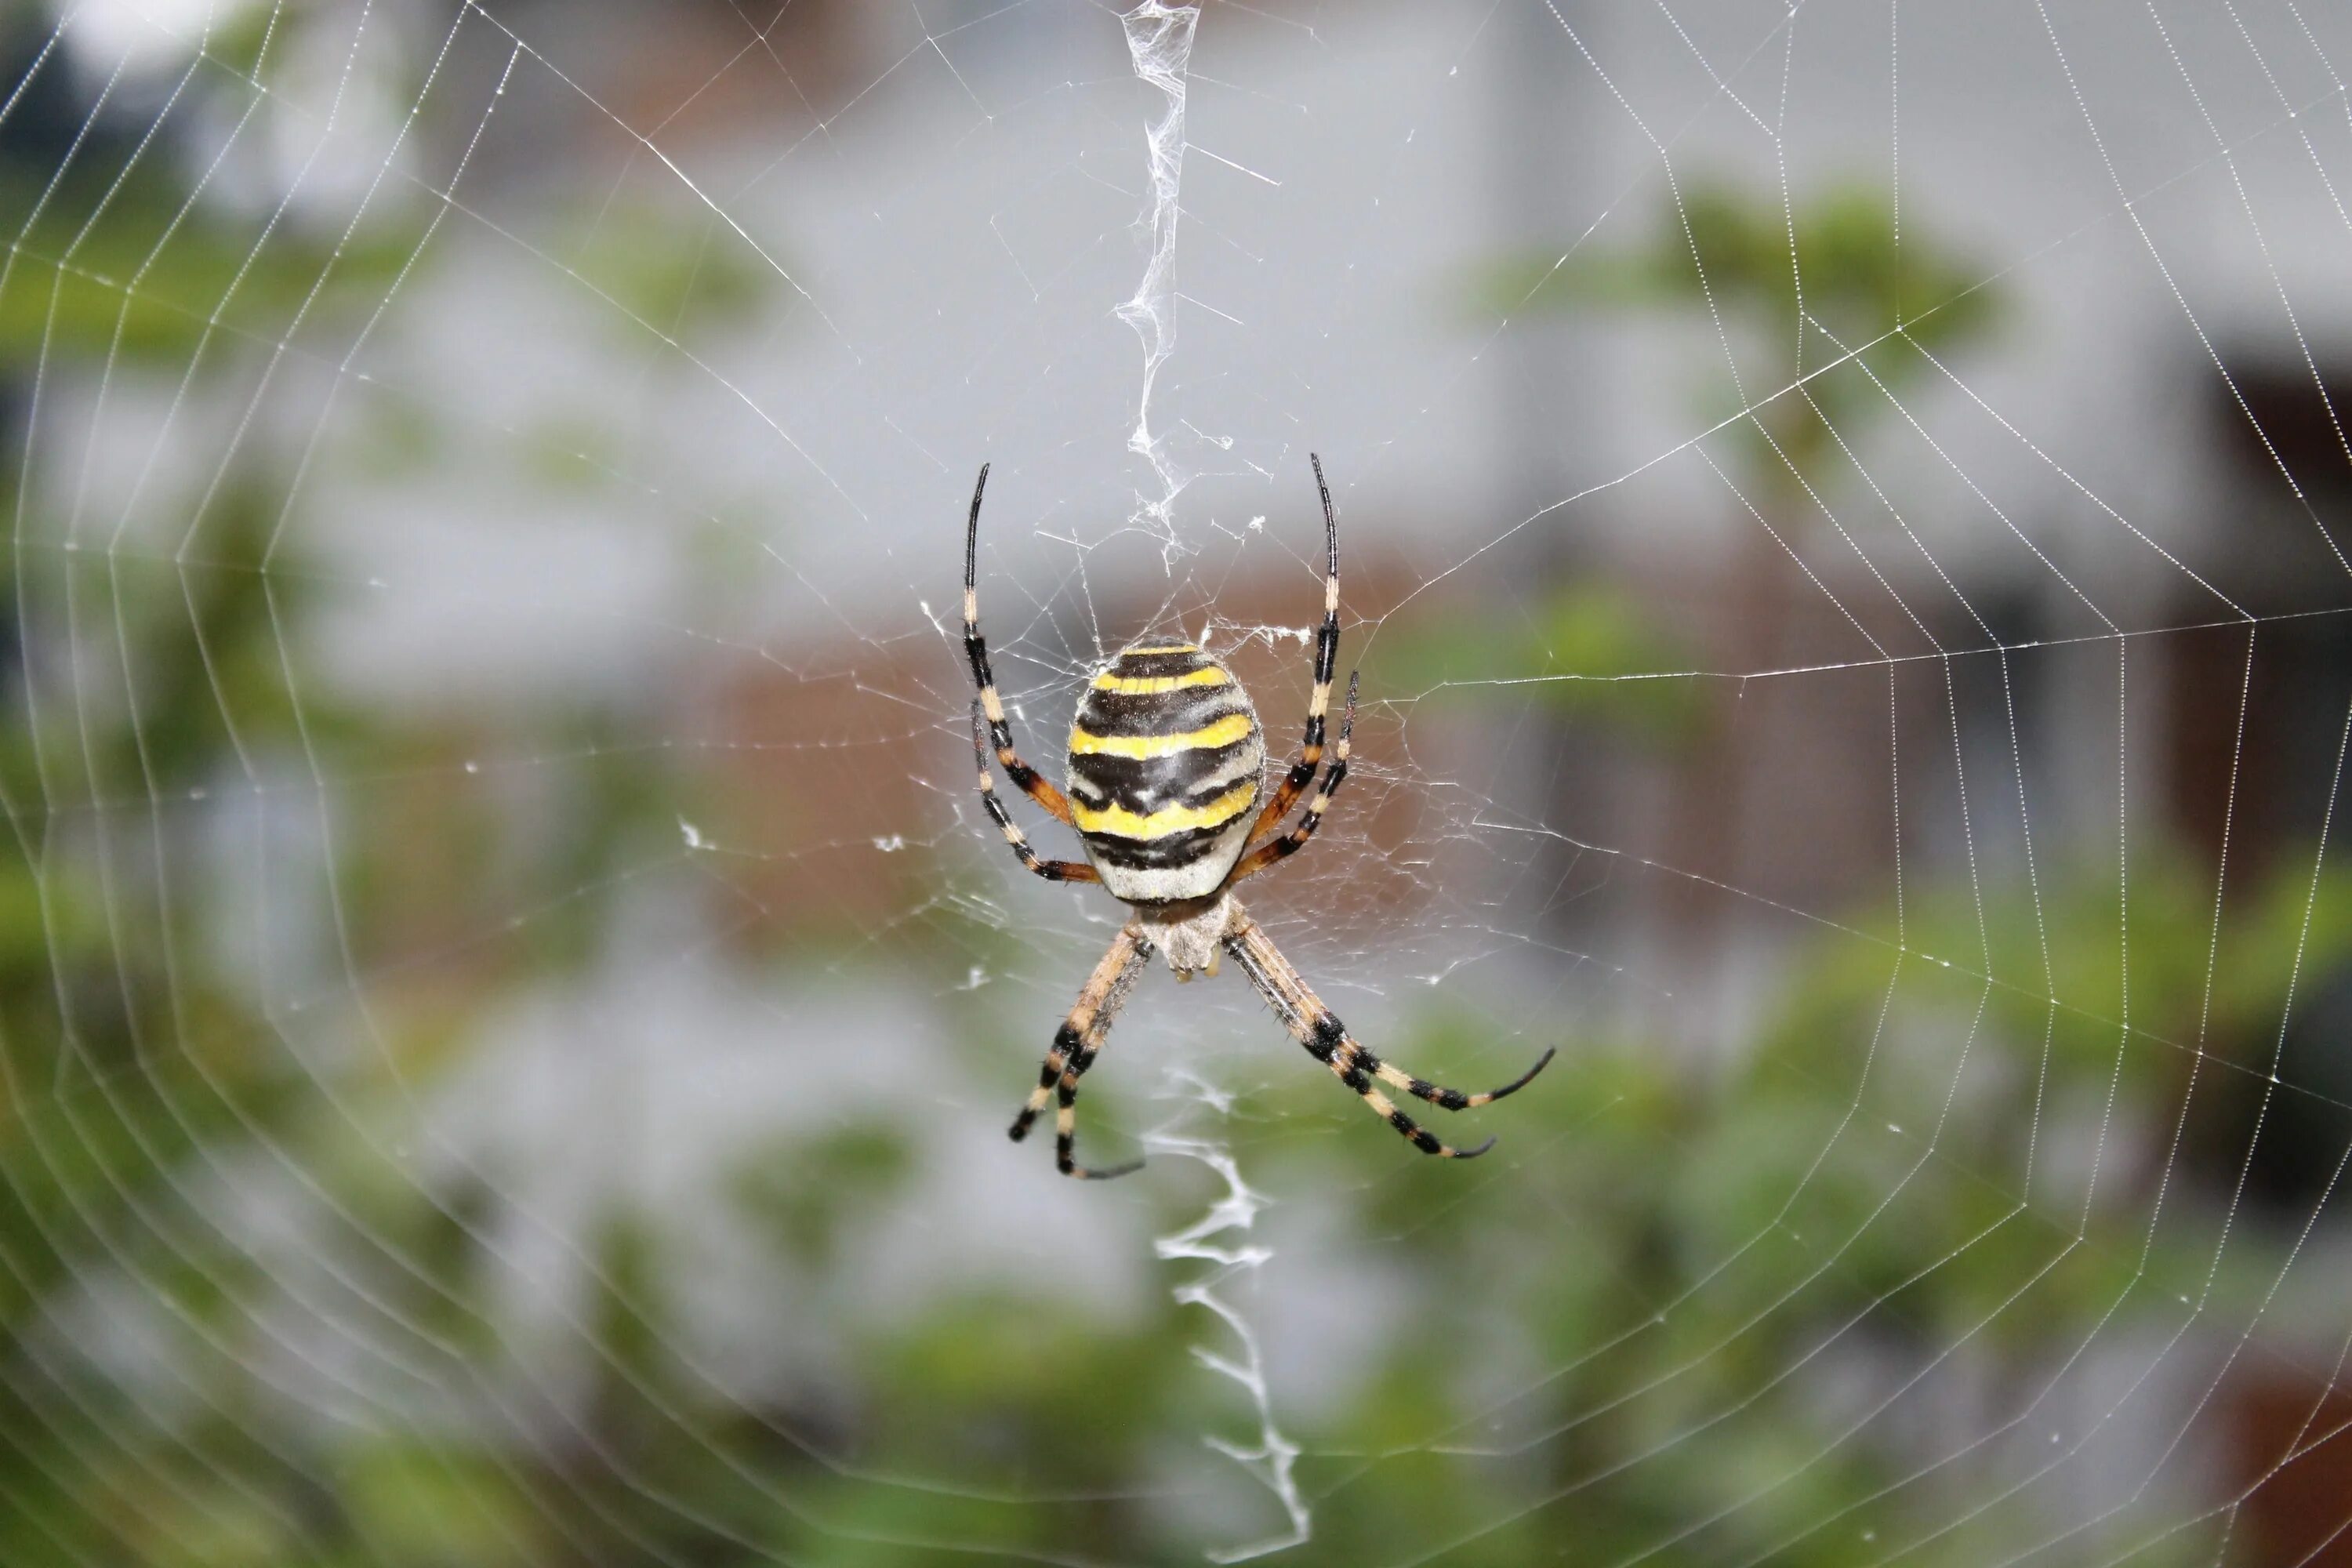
[1214,858,2352,1568]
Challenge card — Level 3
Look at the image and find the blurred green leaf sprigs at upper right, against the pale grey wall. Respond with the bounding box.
[1383,179,2002,743]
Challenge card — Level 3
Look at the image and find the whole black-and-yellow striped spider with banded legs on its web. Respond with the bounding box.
[964,454,1552,1180]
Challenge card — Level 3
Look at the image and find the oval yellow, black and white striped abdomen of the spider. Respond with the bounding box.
[1070,642,1265,902]
